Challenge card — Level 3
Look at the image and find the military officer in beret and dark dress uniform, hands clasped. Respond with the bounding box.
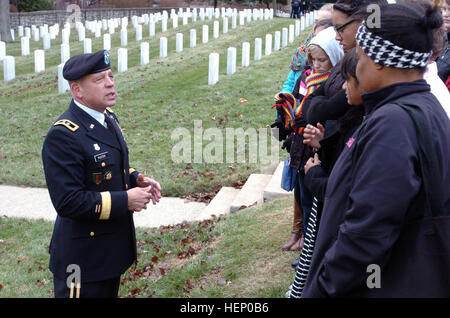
[42,50,161,297]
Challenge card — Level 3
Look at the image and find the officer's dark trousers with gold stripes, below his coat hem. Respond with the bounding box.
[53,276,120,298]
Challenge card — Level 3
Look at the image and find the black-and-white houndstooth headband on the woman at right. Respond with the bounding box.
[356,21,433,68]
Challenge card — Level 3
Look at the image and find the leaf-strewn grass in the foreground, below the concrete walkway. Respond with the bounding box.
[0,198,299,298]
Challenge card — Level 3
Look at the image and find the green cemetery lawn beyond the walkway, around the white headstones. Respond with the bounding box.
[0,18,308,196]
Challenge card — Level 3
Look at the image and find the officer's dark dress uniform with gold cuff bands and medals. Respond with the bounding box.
[42,50,138,297]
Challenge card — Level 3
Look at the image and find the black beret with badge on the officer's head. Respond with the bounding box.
[63,50,111,81]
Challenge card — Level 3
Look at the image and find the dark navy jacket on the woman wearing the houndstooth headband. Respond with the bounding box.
[302,80,450,297]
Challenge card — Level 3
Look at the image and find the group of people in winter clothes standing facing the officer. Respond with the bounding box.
[272,0,450,297]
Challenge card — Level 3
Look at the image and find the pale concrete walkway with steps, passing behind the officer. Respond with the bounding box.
[0,163,292,227]
